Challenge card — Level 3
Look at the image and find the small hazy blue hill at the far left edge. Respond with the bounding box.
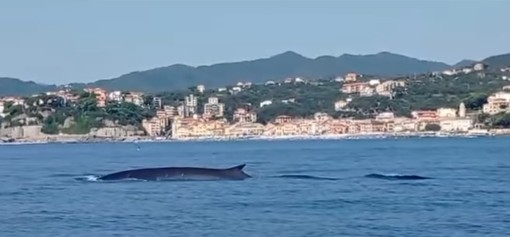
[0,77,56,96]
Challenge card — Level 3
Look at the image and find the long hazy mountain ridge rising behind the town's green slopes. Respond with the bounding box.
[77,51,449,92]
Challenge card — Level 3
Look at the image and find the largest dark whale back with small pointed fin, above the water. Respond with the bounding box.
[98,164,251,181]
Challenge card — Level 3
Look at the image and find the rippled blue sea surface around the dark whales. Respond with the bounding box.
[0,137,510,237]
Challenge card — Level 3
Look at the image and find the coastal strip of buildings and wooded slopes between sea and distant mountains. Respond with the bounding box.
[0,63,510,141]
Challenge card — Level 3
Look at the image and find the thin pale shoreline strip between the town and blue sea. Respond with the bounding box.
[0,132,510,145]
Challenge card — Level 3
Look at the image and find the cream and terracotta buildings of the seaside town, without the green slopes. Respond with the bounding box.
[0,63,510,142]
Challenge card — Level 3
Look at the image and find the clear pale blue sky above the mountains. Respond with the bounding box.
[0,0,510,84]
